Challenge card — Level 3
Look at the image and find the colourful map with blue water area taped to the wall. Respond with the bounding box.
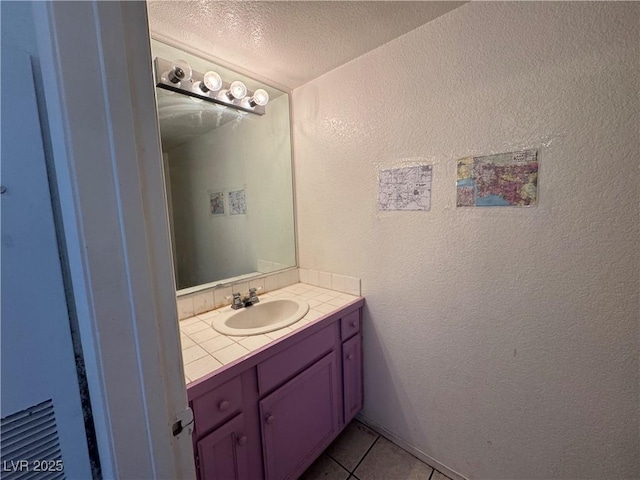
[456,150,538,207]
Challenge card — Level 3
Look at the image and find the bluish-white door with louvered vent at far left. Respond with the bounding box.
[0,45,92,479]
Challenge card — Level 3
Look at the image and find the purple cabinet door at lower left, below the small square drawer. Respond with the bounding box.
[196,414,249,480]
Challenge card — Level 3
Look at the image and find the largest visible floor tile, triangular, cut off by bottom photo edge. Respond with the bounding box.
[353,437,433,480]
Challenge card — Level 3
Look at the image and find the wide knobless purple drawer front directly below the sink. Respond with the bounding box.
[258,324,337,395]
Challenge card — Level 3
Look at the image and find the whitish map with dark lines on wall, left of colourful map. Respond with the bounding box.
[378,165,432,210]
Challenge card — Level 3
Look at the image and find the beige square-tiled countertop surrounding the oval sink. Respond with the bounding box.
[179,283,360,383]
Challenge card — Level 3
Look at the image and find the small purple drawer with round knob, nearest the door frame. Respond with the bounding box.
[193,376,242,435]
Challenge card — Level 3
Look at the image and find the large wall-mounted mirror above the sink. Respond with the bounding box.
[151,40,296,294]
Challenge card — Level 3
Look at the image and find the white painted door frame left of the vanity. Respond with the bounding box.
[32,1,195,478]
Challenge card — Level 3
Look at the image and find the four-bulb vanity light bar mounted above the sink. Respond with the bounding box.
[154,57,269,115]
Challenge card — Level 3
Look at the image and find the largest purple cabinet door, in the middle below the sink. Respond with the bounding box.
[260,352,342,480]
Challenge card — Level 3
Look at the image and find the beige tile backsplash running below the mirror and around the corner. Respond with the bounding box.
[178,268,360,320]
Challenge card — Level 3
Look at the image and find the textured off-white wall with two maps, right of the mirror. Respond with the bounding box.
[293,2,640,479]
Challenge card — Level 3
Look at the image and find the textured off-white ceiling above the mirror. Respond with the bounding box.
[148,0,464,88]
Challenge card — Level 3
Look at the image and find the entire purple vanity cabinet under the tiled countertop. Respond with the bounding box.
[187,299,364,480]
